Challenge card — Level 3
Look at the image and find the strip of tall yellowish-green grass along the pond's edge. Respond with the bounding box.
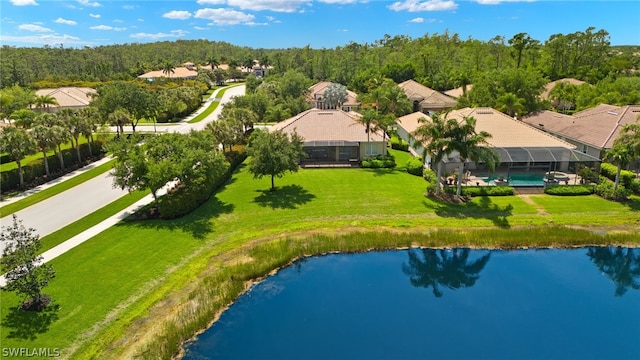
[106,226,640,359]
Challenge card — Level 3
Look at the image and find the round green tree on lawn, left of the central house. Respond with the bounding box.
[247,130,305,191]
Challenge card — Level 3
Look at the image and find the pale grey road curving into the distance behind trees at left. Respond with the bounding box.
[0,85,245,246]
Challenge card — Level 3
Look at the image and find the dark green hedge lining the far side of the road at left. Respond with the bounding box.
[0,140,104,193]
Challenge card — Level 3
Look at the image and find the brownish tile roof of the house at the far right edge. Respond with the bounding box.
[522,104,640,149]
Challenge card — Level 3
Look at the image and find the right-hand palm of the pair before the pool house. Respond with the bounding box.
[451,116,500,196]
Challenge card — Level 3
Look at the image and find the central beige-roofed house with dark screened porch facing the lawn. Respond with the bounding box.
[269,109,387,164]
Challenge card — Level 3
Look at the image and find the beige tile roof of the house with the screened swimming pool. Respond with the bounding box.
[397,108,575,149]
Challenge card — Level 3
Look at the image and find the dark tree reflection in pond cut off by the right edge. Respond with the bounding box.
[587,247,640,296]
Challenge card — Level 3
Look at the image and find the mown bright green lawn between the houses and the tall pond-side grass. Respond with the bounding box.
[0,152,640,358]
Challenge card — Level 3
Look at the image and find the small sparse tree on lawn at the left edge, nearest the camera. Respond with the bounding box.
[0,214,55,311]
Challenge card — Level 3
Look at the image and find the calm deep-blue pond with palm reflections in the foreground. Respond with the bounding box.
[185,248,640,359]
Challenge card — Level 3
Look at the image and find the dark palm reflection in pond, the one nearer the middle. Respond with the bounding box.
[402,249,491,297]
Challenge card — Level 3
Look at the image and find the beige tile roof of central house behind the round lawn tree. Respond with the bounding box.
[270,109,383,143]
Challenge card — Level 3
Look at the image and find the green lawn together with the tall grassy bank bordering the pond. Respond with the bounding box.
[0,150,640,359]
